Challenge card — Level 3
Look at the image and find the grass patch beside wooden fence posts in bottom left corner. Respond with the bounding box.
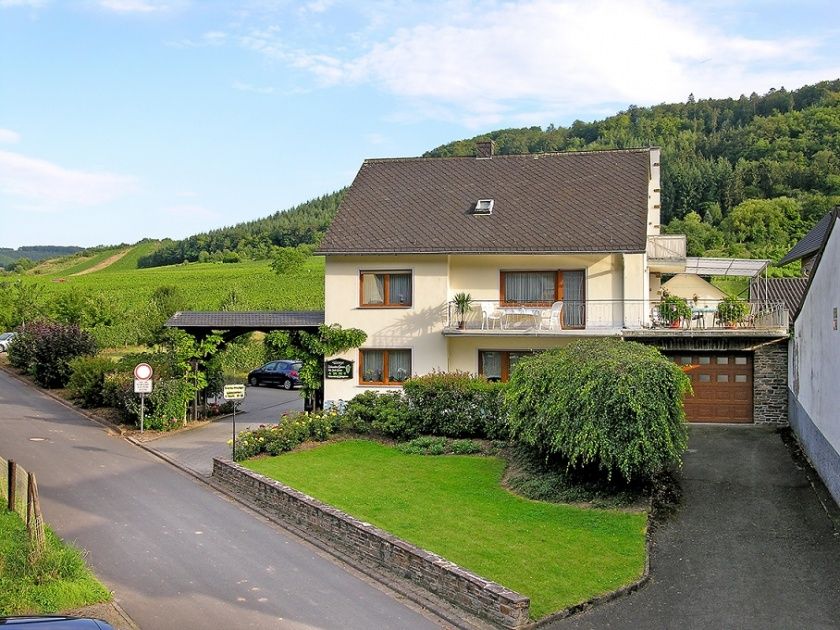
[0,510,111,616]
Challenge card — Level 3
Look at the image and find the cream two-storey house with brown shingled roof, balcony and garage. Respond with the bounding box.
[320,142,787,422]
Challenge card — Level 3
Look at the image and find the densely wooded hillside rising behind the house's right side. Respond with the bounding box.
[426,80,840,273]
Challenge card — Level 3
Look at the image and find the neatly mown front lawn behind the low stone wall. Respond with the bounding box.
[245,440,647,619]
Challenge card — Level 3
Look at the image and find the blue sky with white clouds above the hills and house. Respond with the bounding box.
[0,0,840,252]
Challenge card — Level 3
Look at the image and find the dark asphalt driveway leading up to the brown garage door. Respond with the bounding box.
[552,425,840,630]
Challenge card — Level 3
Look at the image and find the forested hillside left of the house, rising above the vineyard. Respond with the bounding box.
[138,190,344,267]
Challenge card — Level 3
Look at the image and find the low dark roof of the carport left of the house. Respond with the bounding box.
[166,311,324,330]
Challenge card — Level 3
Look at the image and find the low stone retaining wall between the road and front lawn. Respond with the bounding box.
[213,459,531,628]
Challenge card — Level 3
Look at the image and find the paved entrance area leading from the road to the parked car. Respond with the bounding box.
[147,387,303,477]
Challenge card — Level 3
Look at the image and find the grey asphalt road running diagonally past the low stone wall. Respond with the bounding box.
[0,373,436,629]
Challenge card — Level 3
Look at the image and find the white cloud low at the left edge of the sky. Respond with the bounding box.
[0,151,137,210]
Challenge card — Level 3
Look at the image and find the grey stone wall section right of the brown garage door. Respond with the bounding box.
[753,339,788,424]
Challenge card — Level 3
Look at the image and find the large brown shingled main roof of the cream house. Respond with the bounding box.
[319,149,650,254]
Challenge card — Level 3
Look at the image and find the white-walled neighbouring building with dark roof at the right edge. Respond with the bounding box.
[783,209,840,504]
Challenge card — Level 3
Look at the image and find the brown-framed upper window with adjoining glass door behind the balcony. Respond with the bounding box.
[499,269,586,328]
